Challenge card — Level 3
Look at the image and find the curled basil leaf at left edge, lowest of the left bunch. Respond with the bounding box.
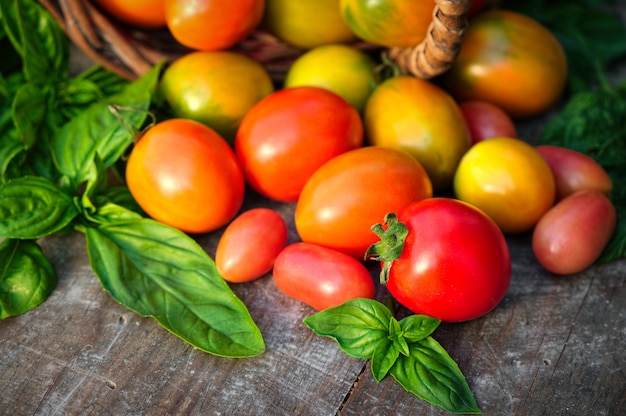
[0,239,57,319]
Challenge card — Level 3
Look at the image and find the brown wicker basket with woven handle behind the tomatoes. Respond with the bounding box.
[40,0,471,81]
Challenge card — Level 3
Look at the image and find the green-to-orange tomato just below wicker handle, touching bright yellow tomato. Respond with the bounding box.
[363,75,471,191]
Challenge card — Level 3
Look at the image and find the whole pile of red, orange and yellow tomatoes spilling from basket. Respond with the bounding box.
[118,0,615,321]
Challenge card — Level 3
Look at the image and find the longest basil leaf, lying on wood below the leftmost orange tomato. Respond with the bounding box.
[84,211,265,357]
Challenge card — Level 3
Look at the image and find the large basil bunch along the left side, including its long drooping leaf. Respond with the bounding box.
[0,0,265,357]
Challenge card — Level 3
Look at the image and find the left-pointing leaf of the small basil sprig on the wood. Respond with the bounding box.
[304,299,391,359]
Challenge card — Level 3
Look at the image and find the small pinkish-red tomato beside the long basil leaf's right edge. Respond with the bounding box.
[215,208,288,283]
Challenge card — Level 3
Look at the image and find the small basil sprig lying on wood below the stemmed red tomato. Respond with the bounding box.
[304,299,481,414]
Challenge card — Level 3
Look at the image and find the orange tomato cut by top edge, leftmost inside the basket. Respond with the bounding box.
[94,0,166,28]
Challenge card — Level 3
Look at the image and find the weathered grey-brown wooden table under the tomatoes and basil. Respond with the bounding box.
[0,26,626,416]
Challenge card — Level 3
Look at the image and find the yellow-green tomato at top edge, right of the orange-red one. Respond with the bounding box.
[261,0,357,50]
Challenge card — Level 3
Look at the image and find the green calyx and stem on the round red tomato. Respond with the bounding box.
[365,212,409,284]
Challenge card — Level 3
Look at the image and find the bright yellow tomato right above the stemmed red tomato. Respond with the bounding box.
[454,137,555,233]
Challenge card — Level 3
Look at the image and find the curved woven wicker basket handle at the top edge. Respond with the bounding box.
[388,0,471,79]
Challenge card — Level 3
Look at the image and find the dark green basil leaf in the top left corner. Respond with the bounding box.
[0,0,70,82]
